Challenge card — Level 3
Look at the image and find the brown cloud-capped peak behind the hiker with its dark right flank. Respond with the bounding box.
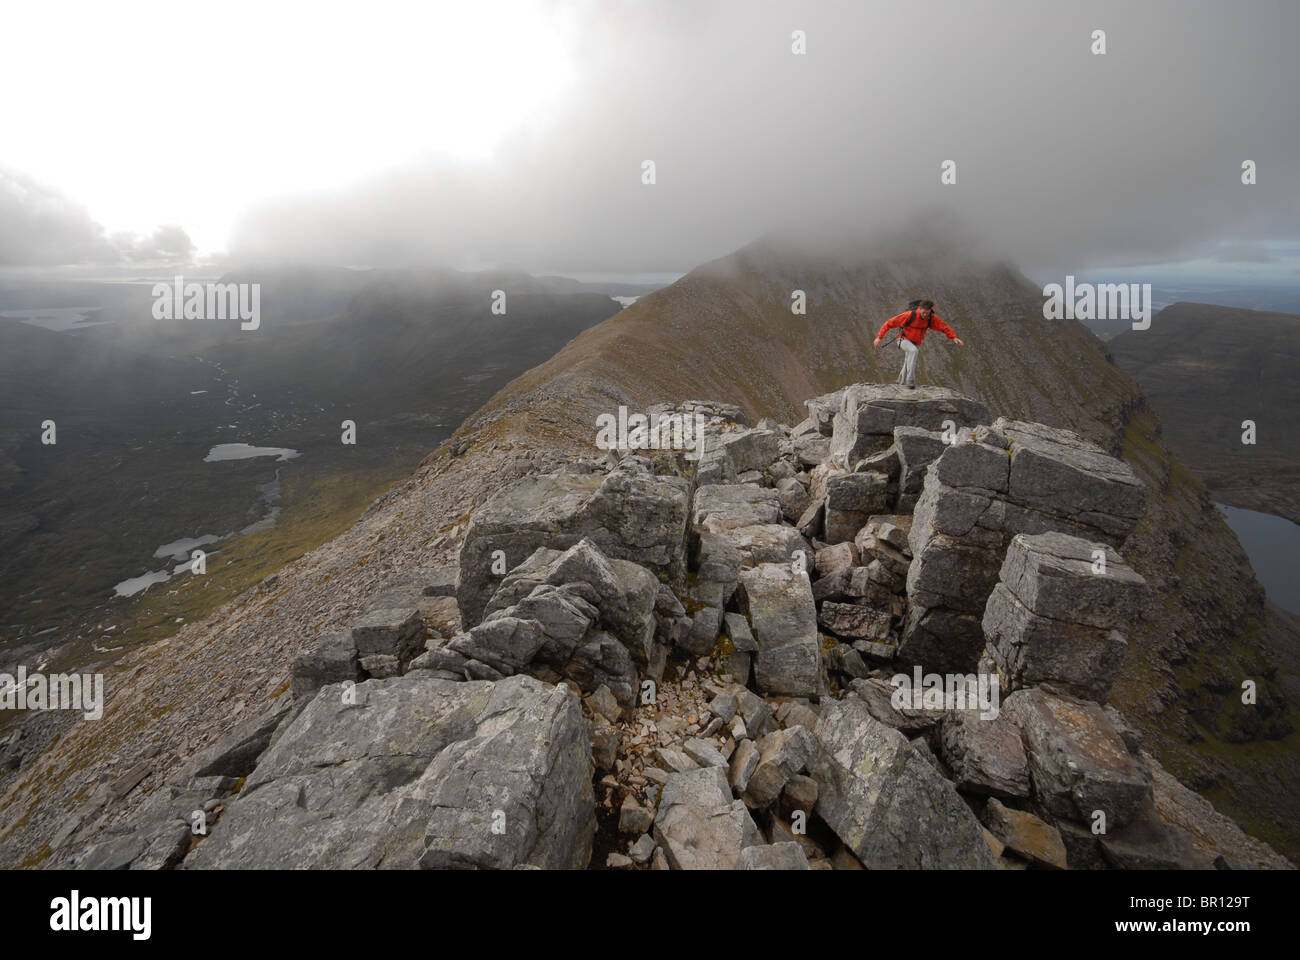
[456,243,1300,856]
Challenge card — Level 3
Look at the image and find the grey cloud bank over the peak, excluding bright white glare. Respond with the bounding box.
[230,1,1300,272]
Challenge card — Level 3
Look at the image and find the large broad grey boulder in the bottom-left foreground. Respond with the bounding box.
[185,671,595,869]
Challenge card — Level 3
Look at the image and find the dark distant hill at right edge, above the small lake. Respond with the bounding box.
[1109,303,1300,523]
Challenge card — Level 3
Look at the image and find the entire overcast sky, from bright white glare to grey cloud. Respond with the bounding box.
[0,0,1300,276]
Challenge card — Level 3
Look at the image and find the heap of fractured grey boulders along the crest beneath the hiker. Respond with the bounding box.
[51,384,1287,869]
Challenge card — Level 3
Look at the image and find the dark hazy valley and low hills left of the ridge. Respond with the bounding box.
[0,271,620,676]
